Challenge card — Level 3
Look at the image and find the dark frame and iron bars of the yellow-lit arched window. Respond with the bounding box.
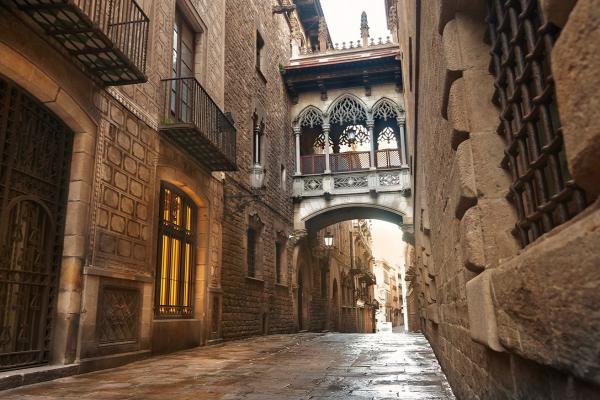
[154,182,198,319]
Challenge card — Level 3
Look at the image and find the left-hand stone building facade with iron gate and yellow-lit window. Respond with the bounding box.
[0,0,235,385]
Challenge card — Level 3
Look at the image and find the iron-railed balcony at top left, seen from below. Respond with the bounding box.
[13,0,149,86]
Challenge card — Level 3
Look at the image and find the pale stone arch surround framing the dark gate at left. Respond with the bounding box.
[0,43,98,364]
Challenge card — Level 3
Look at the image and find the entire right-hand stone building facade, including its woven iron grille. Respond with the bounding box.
[386,0,600,399]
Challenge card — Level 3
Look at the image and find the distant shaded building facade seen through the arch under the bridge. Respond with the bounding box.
[294,220,375,333]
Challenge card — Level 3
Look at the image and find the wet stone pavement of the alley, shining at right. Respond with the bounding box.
[0,333,454,400]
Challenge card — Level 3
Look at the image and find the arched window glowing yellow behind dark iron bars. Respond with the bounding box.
[155,182,197,318]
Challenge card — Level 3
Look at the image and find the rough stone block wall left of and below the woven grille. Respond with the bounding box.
[407,0,600,399]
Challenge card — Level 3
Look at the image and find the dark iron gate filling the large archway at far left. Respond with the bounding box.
[0,76,73,370]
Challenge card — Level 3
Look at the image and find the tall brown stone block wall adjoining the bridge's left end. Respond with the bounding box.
[222,0,296,339]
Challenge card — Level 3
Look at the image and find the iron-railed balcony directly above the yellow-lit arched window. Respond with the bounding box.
[159,78,237,171]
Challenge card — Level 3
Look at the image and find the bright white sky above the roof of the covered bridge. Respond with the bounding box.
[321,0,390,45]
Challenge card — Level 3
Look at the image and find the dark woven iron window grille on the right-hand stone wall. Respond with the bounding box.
[487,0,586,246]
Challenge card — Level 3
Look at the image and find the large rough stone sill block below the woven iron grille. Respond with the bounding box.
[486,201,600,384]
